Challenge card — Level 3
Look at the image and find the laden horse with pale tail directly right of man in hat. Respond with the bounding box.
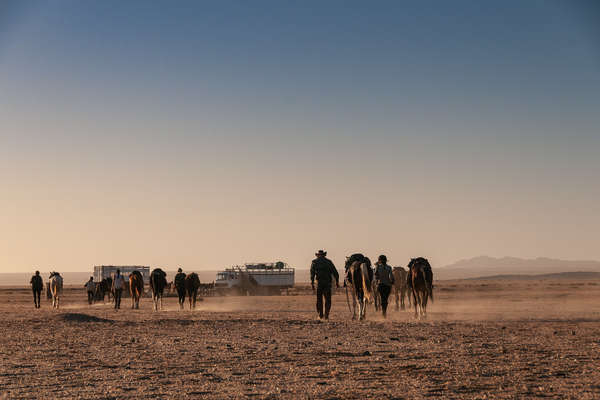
[345,255,373,320]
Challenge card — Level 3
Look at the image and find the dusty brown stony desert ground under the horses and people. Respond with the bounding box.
[0,281,600,399]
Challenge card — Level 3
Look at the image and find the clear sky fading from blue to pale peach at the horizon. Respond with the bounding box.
[0,0,600,272]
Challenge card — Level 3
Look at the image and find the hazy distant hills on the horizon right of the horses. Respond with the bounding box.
[434,256,600,280]
